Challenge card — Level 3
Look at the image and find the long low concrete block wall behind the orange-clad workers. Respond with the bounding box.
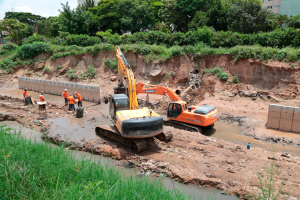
[18,76,100,103]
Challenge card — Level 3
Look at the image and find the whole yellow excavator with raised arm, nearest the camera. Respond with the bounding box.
[95,46,173,153]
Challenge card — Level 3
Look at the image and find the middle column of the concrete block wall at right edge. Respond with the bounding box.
[279,106,295,131]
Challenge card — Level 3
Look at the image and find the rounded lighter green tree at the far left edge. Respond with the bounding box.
[0,19,27,41]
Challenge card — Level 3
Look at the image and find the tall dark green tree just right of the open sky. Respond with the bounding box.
[59,2,92,35]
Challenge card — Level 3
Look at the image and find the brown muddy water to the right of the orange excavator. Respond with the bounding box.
[203,122,300,157]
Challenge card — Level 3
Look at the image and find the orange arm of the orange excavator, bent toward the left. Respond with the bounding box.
[136,82,182,101]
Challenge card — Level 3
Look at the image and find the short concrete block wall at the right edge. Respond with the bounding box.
[267,104,300,133]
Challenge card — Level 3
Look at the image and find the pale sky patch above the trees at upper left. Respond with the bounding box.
[0,0,77,19]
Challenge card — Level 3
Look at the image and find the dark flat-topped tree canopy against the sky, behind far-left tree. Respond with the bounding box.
[4,12,45,26]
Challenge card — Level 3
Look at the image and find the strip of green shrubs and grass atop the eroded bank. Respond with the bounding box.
[0,42,300,72]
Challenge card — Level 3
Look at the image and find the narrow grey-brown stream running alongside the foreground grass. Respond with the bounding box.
[0,120,238,200]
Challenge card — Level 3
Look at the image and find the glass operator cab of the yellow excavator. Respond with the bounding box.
[109,94,129,122]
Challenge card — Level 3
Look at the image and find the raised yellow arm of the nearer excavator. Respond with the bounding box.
[114,46,139,110]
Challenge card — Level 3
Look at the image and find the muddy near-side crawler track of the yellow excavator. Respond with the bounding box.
[95,125,147,153]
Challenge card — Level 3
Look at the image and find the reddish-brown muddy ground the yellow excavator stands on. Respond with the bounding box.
[0,92,300,200]
